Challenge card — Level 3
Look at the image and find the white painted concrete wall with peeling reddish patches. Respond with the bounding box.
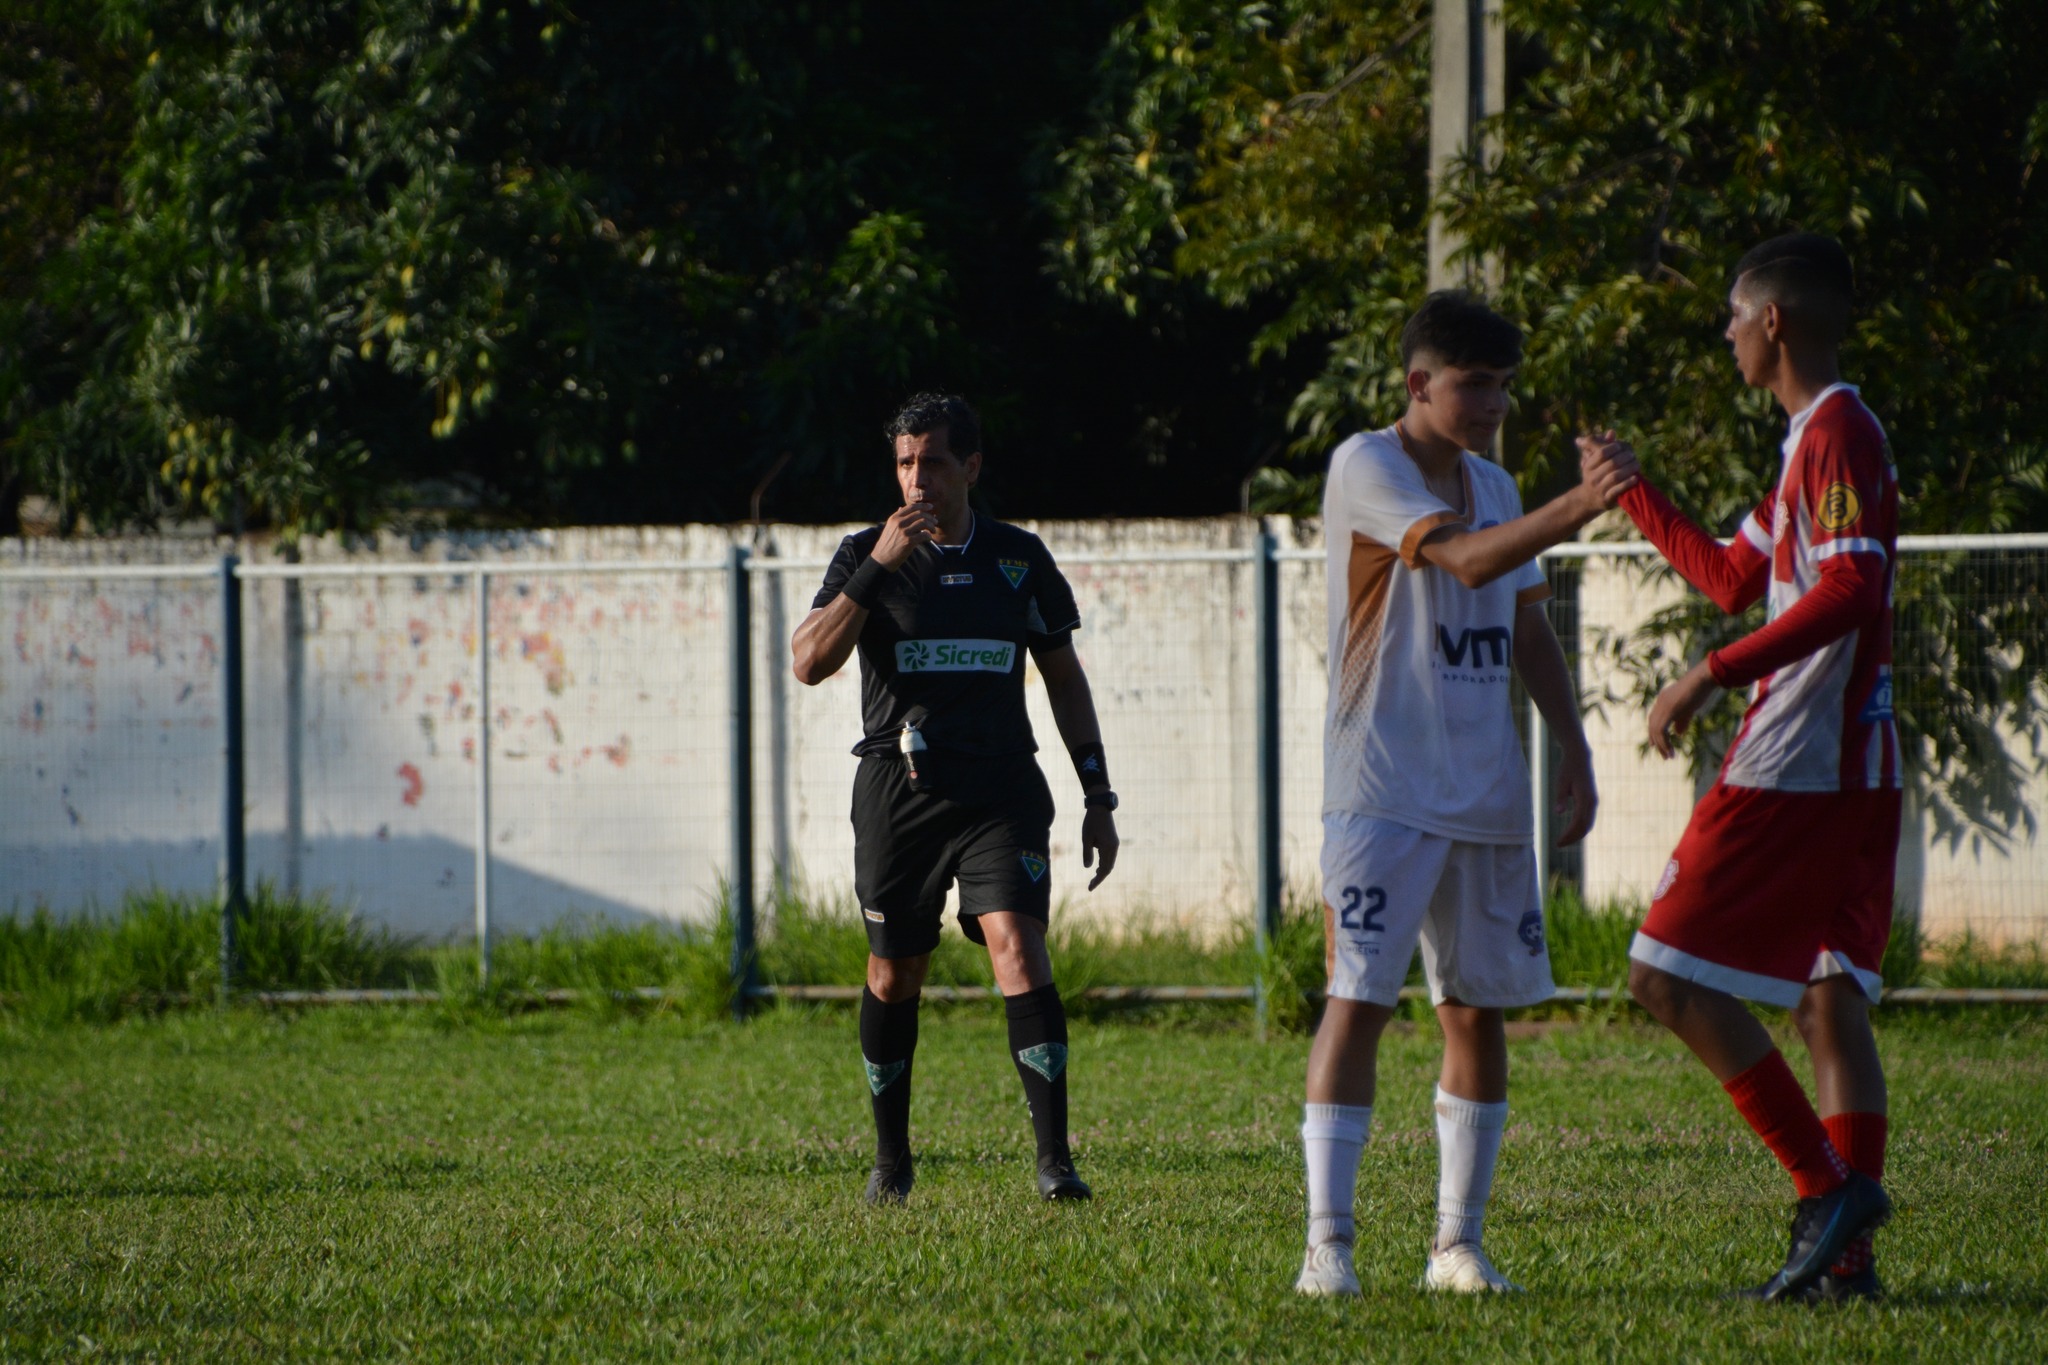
[0,518,2048,937]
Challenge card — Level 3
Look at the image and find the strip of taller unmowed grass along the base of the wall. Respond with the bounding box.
[0,886,2048,1031]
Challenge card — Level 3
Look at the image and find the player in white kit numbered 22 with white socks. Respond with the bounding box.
[1294,293,1634,1293]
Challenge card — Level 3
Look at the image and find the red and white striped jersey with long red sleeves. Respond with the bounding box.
[1622,385,1901,792]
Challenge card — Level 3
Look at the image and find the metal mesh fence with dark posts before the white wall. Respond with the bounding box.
[0,518,2048,982]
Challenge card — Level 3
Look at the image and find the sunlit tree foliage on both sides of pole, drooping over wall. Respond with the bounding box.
[1057,0,2048,835]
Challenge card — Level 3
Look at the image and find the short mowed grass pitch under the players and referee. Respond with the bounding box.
[0,1005,2048,1363]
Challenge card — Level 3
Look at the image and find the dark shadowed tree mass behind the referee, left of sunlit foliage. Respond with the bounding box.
[0,0,1277,534]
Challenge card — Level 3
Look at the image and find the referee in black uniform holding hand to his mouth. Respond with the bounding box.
[793,393,1116,1203]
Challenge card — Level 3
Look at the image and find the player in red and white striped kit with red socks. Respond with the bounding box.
[1579,233,1901,1302]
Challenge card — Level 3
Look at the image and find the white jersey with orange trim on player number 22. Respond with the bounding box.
[1323,428,1550,843]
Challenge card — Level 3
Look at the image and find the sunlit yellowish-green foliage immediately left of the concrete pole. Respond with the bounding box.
[1055,0,1430,454]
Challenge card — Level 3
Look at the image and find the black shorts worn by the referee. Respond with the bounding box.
[854,753,1053,958]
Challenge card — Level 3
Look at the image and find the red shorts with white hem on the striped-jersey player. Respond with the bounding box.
[1628,782,1898,1009]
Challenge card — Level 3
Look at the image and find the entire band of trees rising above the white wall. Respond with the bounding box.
[16,0,2048,552]
